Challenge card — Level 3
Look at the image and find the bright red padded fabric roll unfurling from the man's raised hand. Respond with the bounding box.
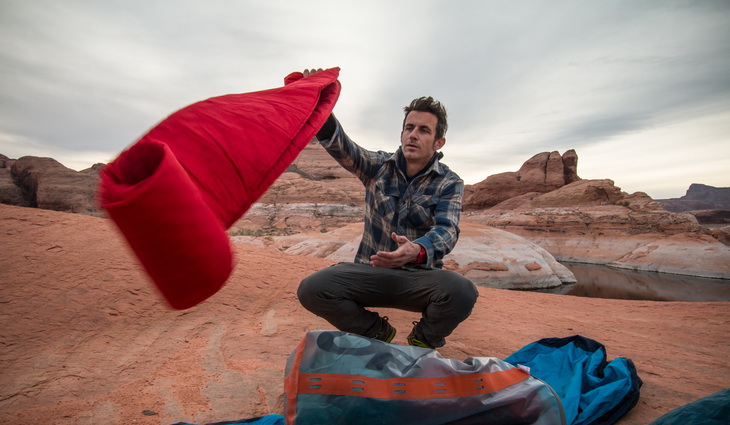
[99,68,340,309]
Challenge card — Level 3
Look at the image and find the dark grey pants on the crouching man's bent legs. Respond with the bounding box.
[297,263,479,347]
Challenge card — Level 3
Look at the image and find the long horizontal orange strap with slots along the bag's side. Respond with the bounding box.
[292,368,530,399]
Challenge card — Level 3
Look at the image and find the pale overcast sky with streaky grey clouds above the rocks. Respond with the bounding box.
[0,0,730,199]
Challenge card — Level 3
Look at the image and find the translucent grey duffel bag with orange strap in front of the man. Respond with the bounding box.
[285,331,565,425]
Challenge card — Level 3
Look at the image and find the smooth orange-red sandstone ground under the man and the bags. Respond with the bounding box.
[0,205,730,425]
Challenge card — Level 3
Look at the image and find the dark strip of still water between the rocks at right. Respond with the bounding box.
[540,263,730,301]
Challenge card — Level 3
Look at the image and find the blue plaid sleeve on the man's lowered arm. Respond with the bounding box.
[413,179,464,268]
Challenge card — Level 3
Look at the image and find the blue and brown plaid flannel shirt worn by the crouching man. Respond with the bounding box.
[320,117,464,269]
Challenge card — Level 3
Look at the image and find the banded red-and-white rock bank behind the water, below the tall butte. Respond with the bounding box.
[463,180,730,279]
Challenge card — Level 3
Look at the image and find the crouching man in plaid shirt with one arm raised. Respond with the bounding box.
[298,70,478,348]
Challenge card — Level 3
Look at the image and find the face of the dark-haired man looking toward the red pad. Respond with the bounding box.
[400,111,446,165]
